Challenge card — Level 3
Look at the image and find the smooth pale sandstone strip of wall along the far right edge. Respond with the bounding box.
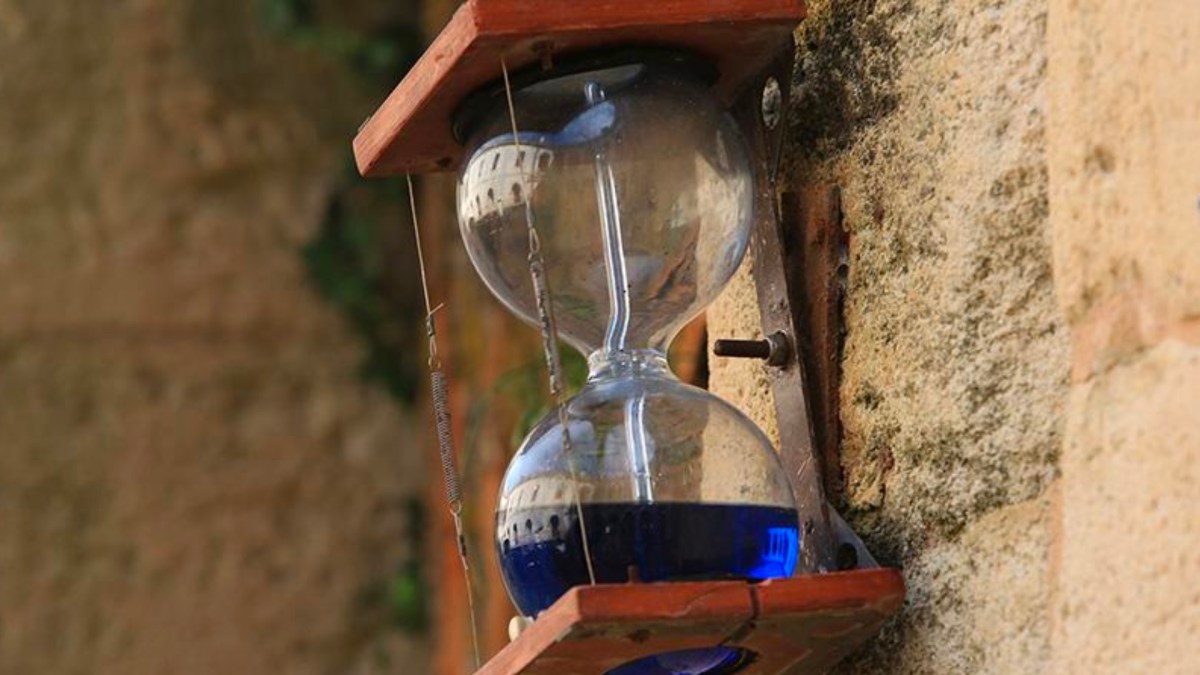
[1048,0,1200,673]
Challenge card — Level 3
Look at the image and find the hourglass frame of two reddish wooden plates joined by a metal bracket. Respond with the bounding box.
[354,0,905,675]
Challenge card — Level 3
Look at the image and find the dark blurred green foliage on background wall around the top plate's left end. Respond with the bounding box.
[258,0,422,405]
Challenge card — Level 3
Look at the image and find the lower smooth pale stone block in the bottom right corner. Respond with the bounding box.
[1054,341,1200,674]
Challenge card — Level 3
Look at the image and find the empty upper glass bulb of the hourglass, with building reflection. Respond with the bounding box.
[457,59,754,353]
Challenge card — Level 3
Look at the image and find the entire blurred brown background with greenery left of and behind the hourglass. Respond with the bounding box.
[0,0,703,675]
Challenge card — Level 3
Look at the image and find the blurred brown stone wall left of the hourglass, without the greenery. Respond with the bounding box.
[0,0,426,675]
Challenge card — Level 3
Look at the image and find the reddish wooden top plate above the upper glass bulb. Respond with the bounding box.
[354,0,804,177]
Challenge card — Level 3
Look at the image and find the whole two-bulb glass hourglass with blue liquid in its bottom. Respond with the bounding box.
[457,59,799,673]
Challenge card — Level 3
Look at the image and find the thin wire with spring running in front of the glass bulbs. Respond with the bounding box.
[500,56,596,585]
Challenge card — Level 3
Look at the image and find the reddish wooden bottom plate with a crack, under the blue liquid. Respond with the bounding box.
[478,569,904,675]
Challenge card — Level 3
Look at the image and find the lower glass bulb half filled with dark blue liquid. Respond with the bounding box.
[496,352,800,616]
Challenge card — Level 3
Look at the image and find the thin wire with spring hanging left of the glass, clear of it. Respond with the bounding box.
[404,174,481,670]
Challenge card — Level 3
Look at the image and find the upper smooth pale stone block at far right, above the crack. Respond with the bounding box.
[1048,0,1200,329]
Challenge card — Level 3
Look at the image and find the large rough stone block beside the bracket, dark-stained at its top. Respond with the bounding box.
[792,0,1068,542]
